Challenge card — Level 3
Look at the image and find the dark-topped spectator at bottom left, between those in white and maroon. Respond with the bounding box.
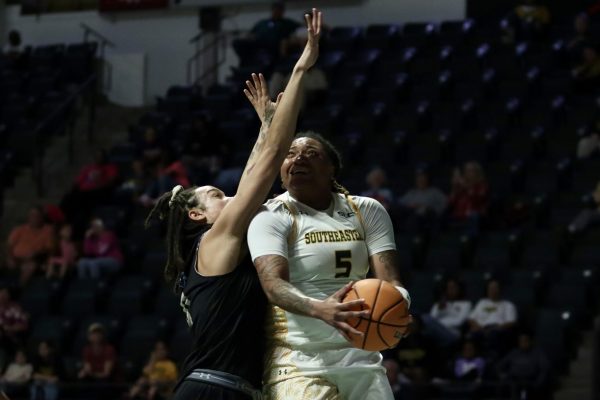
[29,340,64,400]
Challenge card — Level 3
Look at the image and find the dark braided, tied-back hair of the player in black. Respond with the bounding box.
[145,185,210,292]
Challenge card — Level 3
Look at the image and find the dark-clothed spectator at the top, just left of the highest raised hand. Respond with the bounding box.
[250,1,302,59]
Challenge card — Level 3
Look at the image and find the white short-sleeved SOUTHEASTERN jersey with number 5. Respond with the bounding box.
[248,193,396,351]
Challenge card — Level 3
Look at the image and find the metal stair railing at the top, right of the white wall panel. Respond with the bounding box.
[187,32,230,88]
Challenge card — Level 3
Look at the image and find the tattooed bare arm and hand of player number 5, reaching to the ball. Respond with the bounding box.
[254,255,368,338]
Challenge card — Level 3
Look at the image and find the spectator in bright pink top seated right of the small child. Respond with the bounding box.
[77,218,123,278]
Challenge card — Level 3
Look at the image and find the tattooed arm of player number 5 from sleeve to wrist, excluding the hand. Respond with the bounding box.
[255,256,313,315]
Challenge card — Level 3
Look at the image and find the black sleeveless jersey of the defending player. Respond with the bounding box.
[181,233,267,388]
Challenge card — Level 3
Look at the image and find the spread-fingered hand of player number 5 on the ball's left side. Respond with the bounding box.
[316,282,370,341]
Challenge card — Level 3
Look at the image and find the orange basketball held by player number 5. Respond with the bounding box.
[343,279,410,351]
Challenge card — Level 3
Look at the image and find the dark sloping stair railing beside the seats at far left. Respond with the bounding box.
[32,74,98,196]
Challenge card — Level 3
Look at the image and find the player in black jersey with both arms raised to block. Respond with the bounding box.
[148,9,363,400]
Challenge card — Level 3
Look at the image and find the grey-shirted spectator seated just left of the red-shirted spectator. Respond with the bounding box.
[399,167,447,233]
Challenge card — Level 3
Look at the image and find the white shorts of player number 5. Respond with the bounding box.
[263,347,394,400]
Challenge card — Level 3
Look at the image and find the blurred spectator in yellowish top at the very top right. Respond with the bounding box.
[503,0,550,43]
